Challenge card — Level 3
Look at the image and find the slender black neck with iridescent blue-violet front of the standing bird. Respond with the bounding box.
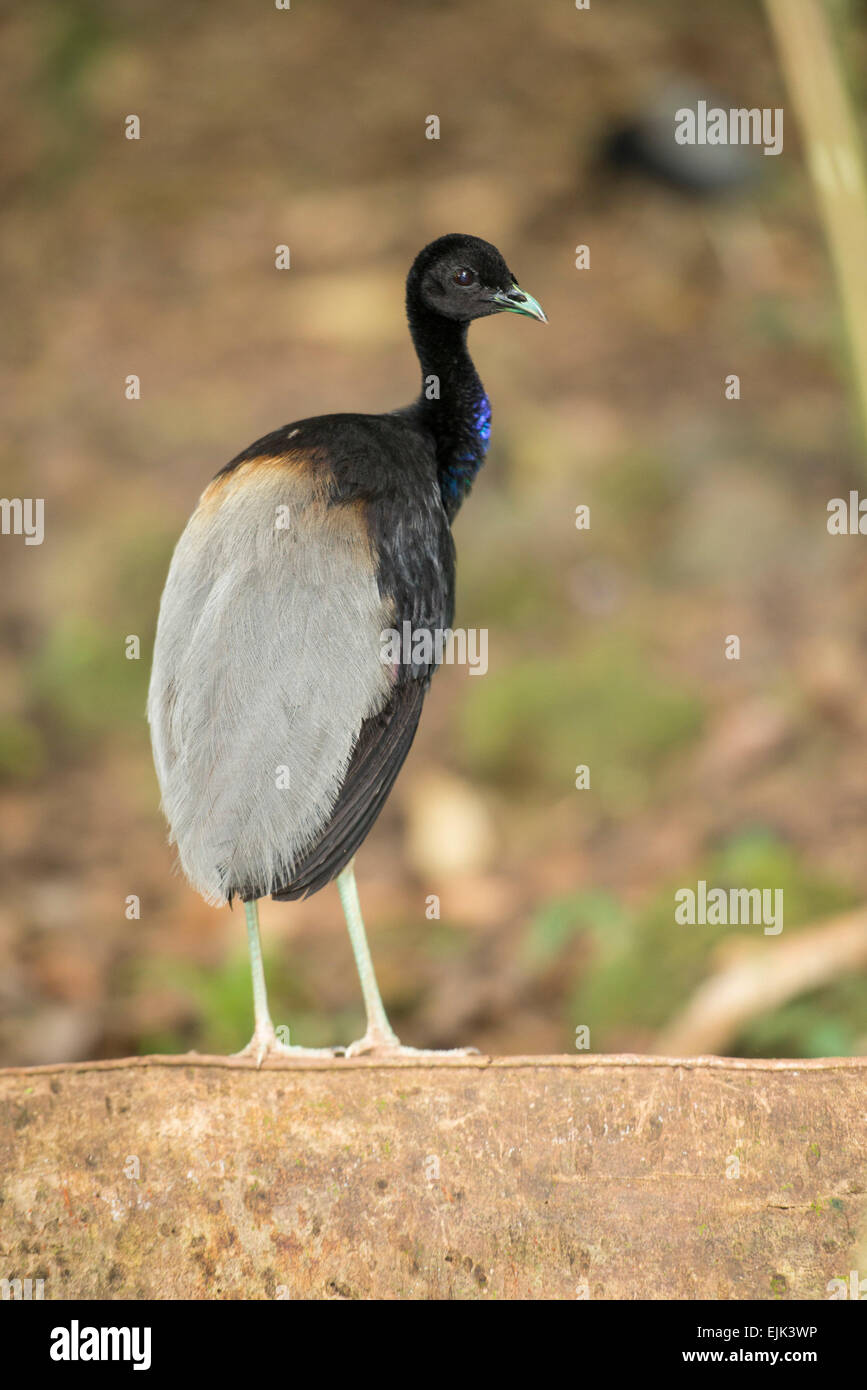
[408,307,490,518]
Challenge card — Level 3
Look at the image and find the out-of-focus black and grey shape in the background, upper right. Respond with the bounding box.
[599,82,759,197]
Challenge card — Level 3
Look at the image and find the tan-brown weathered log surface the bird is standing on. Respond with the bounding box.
[0,1054,867,1300]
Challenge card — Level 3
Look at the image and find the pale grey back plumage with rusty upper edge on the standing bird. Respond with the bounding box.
[147,460,392,904]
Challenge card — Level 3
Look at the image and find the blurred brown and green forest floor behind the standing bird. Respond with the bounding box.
[0,0,867,1062]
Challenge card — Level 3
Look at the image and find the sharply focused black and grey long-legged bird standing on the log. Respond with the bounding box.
[147,235,546,1063]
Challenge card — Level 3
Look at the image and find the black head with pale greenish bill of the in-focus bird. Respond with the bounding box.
[407,232,547,324]
